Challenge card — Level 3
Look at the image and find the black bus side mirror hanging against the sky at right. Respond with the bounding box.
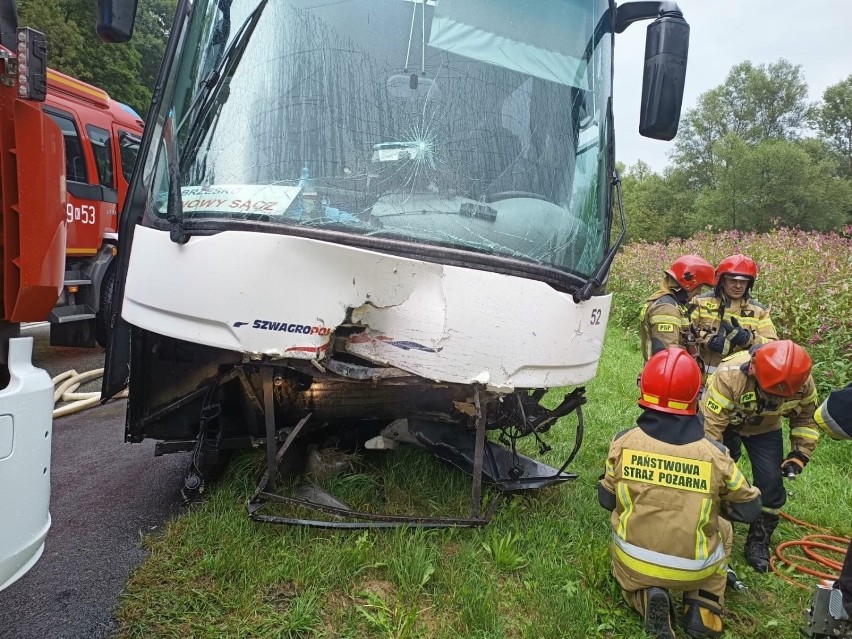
[639,12,689,141]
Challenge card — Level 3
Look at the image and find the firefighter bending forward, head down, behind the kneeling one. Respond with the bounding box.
[701,340,819,572]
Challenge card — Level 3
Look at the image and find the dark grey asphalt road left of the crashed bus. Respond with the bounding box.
[0,327,187,639]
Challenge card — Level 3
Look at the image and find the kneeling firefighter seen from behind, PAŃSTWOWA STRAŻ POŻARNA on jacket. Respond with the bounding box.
[598,346,761,638]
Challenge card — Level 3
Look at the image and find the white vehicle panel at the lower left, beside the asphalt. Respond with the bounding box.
[0,337,53,590]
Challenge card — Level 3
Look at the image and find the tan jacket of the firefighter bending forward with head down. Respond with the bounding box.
[700,352,819,458]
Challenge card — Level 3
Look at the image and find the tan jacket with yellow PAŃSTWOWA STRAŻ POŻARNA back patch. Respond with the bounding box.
[601,428,760,582]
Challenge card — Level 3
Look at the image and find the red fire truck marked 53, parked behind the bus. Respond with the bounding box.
[42,69,143,347]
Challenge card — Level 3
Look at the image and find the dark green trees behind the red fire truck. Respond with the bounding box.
[18,0,177,117]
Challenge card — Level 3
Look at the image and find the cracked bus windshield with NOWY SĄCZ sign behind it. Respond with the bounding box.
[157,0,611,275]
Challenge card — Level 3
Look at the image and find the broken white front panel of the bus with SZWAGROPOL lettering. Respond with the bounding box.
[122,227,611,391]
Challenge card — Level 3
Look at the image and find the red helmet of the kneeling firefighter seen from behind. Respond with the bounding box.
[639,346,701,415]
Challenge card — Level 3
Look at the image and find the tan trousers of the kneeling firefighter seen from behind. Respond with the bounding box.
[612,517,734,616]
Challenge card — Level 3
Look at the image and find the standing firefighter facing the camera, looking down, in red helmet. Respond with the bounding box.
[692,254,778,378]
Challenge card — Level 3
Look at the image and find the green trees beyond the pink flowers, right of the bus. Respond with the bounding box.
[620,59,852,242]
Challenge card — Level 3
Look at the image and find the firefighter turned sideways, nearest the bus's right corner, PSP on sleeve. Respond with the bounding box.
[640,255,716,362]
